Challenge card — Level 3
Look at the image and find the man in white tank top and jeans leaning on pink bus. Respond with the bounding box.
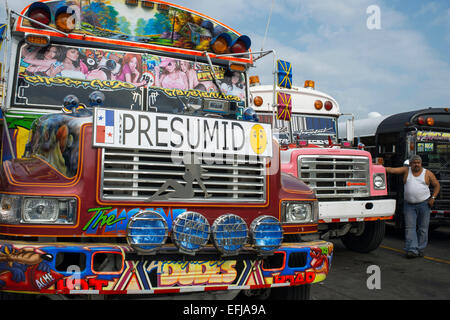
[386,155,441,259]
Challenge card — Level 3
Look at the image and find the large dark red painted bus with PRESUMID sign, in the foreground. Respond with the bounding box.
[0,0,333,299]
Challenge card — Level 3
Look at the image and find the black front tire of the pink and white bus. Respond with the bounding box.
[341,220,386,253]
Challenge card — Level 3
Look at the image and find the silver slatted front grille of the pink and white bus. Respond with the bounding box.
[298,155,370,199]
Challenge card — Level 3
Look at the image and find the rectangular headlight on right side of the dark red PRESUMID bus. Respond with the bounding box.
[282,201,318,223]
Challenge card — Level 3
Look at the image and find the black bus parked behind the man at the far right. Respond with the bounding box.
[355,108,450,229]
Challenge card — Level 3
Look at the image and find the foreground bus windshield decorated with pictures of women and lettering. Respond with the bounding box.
[14,44,246,116]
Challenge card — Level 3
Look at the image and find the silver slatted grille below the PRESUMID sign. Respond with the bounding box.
[101,148,266,203]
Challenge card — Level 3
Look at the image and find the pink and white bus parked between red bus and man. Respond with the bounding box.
[250,72,395,252]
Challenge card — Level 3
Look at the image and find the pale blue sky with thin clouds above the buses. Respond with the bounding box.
[0,0,450,119]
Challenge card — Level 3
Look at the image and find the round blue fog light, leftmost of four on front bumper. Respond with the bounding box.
[127,211,168,253]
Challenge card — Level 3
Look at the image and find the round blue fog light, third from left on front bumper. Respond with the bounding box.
[212,214,248,255]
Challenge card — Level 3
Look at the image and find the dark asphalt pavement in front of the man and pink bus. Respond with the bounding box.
[311,226,450,300]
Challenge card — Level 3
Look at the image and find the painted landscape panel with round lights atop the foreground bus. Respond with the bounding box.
[15,0,253,63]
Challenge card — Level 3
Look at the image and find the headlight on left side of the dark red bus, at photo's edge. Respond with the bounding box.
[0,194,77,224]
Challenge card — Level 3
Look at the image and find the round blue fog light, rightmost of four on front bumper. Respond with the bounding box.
[250,216,283,254]
